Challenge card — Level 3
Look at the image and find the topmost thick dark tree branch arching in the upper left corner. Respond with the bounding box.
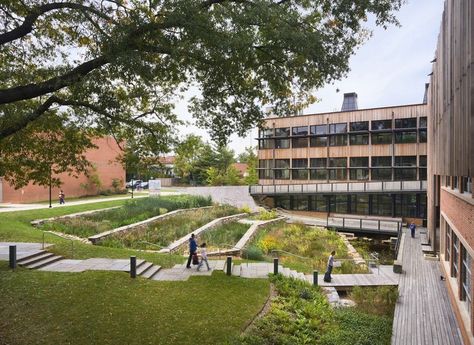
[0,2,114,45]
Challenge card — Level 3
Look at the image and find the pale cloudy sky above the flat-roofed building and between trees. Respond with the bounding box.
[175,0,444,154]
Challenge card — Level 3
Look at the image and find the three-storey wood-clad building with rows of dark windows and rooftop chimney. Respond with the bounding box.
[250,93,427,224]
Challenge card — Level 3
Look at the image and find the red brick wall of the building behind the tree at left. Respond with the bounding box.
[0,137,125,203]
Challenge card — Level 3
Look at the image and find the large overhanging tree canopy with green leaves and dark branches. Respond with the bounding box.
[0,0,402,185]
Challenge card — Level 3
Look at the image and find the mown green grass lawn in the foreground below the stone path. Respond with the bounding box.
[0,262,269,345]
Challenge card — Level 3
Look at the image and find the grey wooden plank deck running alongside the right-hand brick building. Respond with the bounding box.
[392,228,462,345]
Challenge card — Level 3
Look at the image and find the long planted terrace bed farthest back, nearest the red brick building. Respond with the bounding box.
[40,195,212,237]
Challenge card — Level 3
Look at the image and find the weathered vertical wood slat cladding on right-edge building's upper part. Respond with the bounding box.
[428,0,474,176]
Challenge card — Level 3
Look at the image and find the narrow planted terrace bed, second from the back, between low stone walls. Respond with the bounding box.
[100,205,238,250]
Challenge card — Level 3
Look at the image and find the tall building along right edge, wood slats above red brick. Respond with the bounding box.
[428,0,474,344]
